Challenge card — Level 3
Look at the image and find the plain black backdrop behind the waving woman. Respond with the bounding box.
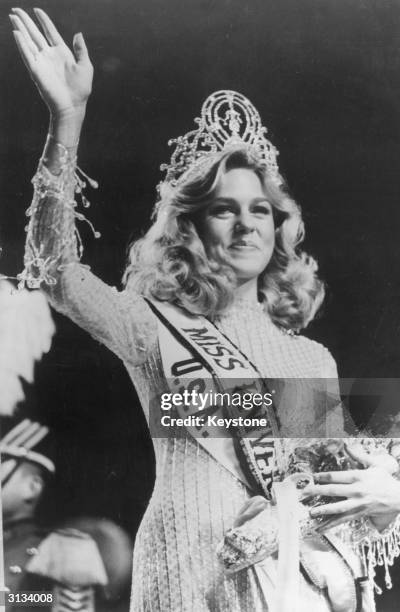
[0,0,400,611]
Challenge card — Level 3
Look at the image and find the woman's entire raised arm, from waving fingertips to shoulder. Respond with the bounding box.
[10,9,155,363]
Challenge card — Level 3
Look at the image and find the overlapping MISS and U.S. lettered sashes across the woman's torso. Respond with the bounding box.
[146,300,283,497]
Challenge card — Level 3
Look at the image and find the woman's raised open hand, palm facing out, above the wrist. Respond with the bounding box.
[10,8,93,119]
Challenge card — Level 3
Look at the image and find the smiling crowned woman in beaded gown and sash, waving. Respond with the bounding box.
[11,9,398,612]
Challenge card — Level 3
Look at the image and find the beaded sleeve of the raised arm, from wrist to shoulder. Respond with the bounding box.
[18,138,156,364]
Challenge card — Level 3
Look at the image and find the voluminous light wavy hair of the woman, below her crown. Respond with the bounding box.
[123,148,324,331]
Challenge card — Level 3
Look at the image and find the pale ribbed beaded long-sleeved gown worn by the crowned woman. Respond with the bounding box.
[25,160,336,612]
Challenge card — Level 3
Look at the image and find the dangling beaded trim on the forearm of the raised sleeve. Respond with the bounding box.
[17,137,100,289]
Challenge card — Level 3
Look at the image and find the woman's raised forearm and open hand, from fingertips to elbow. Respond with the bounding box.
[10,9,93,287]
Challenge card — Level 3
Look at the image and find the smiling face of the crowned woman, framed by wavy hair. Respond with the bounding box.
[201,168,275,284]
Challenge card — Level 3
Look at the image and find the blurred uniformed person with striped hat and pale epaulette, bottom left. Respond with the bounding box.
[0,419,107,612]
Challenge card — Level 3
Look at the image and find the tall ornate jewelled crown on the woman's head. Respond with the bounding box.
[160,89,279,187]
